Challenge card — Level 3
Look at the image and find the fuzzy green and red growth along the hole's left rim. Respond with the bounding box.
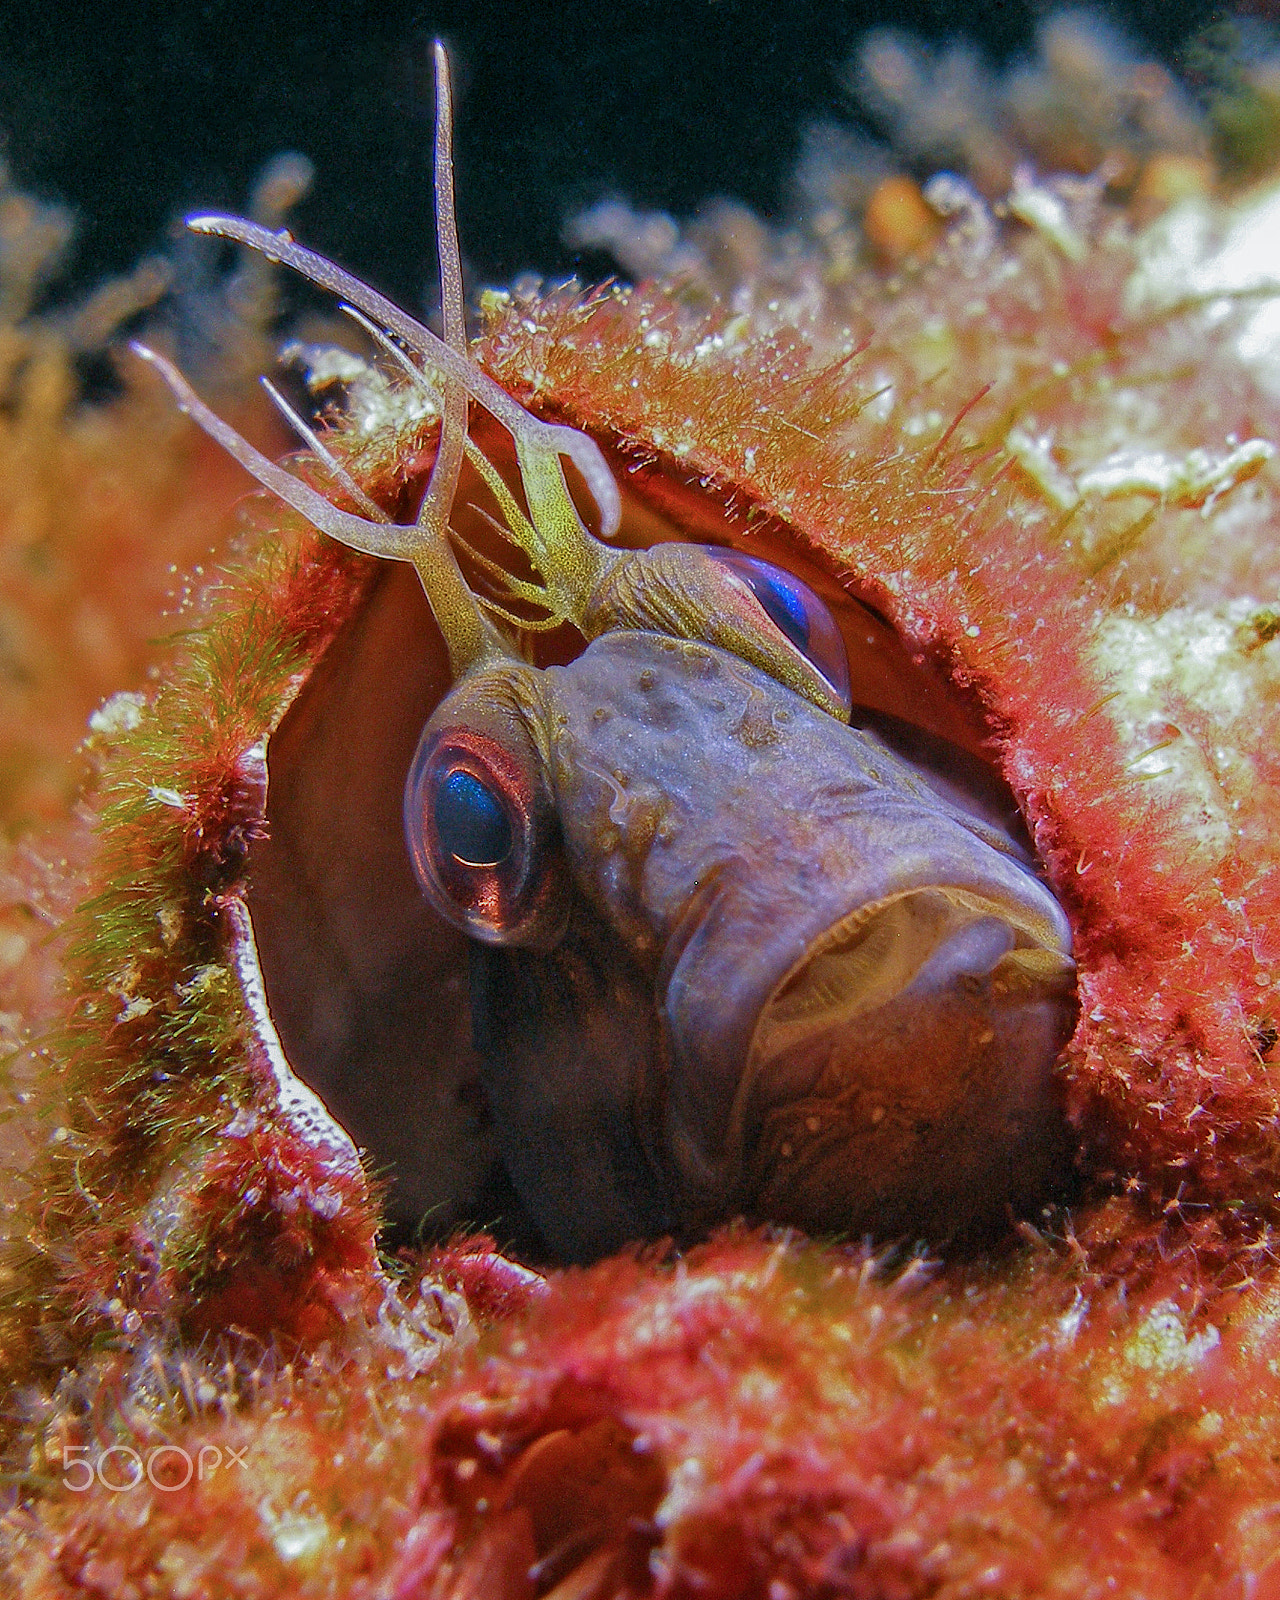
[3,521,386,1401]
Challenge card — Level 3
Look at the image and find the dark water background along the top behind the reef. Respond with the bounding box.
[0,0,1241,306]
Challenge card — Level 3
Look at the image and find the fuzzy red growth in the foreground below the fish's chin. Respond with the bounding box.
[16,1237,1280,1600]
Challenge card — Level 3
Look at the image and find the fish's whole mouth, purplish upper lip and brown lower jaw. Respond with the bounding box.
[659,851,1075,1238]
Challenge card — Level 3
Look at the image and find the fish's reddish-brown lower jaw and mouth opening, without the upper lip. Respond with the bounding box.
[665,885,1075,1238]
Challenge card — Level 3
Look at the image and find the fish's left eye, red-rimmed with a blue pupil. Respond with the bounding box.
[405,723,565,947]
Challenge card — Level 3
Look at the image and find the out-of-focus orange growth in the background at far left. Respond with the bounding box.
[0,150,306,1100]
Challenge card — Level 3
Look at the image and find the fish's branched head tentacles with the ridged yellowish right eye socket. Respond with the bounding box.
[134,46,848,715]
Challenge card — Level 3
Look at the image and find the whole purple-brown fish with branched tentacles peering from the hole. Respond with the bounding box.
[134,51,1075,1261]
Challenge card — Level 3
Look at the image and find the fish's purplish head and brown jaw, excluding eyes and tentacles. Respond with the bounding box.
[406,630,1075,1259]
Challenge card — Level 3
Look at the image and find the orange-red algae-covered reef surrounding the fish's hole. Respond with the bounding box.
[5,16,1280,1600]
